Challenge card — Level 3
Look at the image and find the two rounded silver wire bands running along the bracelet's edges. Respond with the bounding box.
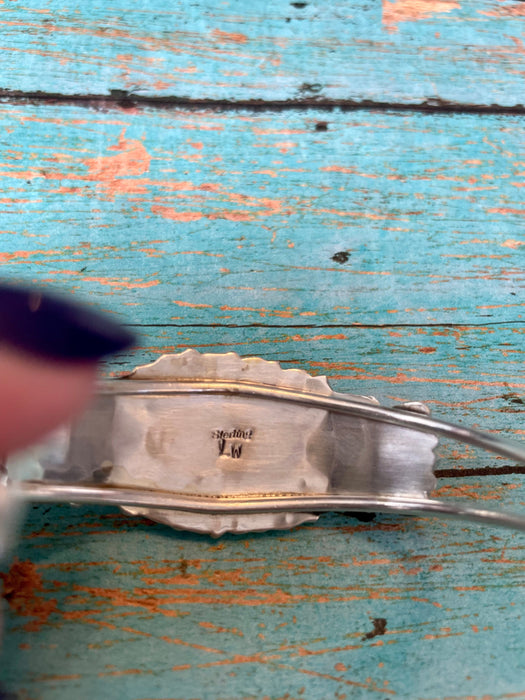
[9,379,525,530]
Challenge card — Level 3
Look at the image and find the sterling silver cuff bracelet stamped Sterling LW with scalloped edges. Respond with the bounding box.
[7,350,525,535]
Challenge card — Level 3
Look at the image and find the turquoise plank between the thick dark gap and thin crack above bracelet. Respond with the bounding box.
[0,102,525,327]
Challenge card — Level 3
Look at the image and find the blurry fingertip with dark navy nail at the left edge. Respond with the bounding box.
[0,285,132,454]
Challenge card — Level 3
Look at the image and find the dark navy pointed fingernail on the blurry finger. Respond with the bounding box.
[0,284,134,361]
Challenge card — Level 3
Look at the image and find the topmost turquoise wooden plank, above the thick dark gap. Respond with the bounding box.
[0,0,525,107]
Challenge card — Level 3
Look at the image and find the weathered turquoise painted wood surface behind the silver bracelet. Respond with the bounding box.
[0,0,525,700]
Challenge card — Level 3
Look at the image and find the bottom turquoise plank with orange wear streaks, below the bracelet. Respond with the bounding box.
[2,498,525,700]
